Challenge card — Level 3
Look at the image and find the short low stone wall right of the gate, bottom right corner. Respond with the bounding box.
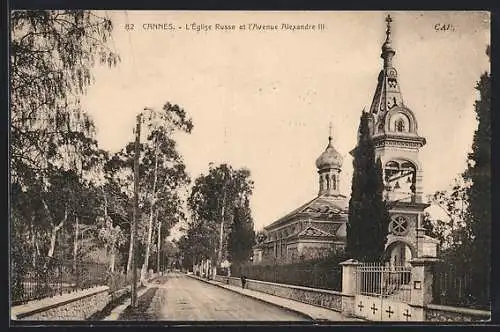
[424,304,491,322]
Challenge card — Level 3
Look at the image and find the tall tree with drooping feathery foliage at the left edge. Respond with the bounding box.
[10,10,119,272]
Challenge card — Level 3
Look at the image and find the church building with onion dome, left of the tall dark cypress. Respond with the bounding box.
[254,128,348,263]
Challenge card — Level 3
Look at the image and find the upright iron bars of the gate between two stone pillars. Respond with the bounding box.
[356,263,411,302]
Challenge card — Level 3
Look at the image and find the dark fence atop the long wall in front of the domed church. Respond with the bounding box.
[231,264,342,291]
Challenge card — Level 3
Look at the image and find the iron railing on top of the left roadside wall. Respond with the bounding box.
[11,257,109,305]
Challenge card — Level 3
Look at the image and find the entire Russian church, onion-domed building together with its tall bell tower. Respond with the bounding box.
[254,16,438,265]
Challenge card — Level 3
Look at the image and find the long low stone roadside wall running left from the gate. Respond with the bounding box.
[215,276,342,311]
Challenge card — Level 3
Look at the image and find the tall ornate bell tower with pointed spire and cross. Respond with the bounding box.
[364,15,436,265]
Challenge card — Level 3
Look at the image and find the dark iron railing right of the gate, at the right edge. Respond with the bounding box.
[432,263,491,310]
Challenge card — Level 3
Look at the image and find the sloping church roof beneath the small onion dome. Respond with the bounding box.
[264,195,348,230]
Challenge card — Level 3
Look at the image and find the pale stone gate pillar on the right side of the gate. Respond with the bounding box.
[409,257,439,321]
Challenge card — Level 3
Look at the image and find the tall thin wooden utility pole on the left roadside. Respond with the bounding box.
[131,114,142,308]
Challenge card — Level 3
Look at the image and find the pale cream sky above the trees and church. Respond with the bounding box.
[82,11,490,233]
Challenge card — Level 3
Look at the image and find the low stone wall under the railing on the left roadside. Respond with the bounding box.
[11,286,113,320]
